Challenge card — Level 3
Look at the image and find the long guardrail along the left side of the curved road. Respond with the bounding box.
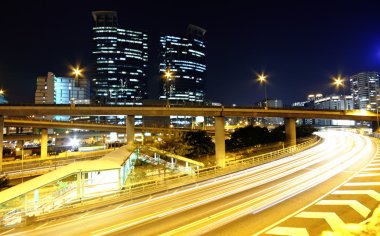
[17,136,321,223]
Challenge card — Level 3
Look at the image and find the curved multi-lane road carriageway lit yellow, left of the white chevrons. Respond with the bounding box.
[0,131,380,235]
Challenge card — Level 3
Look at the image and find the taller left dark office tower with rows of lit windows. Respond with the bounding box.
[91,11,148,105]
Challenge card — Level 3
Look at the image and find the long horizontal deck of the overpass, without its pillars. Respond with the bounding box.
[0,104,377,121]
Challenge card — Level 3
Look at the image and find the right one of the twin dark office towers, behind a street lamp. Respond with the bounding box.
[160,25,206,104]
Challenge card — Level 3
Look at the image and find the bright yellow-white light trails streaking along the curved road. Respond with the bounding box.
[5,132,373,235]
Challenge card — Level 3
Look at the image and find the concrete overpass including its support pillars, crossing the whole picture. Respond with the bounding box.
[0,104,378,170]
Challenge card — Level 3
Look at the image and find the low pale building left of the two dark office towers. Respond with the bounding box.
[34,72,90,104]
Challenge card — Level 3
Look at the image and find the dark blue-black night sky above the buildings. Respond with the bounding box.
[0,0,380,105]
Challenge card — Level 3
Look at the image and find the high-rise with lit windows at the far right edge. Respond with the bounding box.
[350,72,379,112]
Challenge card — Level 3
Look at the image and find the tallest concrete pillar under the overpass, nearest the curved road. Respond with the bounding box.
[215,116,226,168]
